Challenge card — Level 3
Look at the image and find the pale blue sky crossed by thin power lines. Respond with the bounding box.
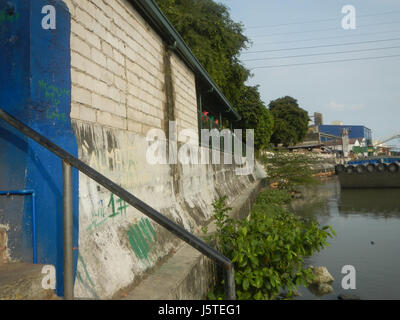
[218,0,400,146]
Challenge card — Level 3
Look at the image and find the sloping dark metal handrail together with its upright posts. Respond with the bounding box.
[0,108,236,300]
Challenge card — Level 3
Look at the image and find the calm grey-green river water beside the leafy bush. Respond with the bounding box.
[293,178,400,300]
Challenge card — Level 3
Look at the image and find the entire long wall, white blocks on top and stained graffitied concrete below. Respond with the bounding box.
[61,0,255,298]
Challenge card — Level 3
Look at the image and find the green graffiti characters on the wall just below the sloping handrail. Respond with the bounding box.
[86,193,129,231]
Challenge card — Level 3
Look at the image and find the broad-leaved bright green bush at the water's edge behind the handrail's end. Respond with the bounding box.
[209,189,335,300]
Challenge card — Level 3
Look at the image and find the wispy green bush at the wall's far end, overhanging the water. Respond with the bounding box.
[260,151,317,192]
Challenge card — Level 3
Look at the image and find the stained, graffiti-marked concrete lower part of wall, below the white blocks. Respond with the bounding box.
[71,121,254,298]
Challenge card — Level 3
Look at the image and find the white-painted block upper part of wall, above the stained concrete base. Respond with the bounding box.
[65,0,202,135]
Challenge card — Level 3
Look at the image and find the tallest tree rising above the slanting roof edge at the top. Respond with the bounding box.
[156,0,250,105]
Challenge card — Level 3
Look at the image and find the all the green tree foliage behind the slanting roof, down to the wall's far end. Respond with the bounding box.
[156,0,273,149]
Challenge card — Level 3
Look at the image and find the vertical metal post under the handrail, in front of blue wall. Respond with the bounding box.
[62,161,74,300]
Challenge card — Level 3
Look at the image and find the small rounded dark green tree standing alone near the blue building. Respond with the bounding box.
[269,96,309,146]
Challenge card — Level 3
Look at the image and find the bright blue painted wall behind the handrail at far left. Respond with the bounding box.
[0,0,79,295]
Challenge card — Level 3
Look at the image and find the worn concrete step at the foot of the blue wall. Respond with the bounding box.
[0,262,60,300]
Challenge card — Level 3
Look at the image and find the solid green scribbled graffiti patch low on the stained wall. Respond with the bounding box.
[128,218,156,262]
